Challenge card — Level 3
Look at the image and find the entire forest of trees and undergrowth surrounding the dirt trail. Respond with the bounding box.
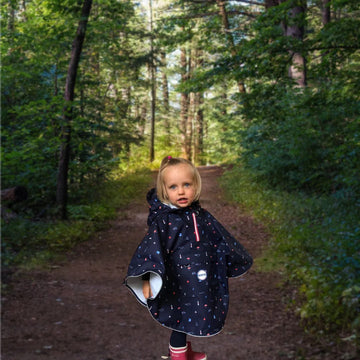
[1,0,360,348]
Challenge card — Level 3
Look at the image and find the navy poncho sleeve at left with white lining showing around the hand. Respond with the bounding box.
[125,222,165,306]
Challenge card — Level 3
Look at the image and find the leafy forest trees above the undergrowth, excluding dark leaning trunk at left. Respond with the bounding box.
[2,0,360,210]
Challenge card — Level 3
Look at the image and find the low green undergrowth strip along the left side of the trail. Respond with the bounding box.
[1,169,150,269]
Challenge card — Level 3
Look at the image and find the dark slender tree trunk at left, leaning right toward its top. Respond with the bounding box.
[56,0,92,219]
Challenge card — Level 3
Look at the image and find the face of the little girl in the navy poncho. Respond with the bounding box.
[163,164,196,208]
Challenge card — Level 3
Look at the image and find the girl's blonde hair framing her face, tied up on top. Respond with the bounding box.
[156,156,201,203]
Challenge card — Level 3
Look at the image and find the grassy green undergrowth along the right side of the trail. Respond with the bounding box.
[221,168,360,346]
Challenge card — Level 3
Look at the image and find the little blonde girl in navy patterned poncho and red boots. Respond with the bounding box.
[125,156,252,360]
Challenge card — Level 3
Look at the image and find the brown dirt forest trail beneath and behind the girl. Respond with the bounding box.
[2,167,340,360]
